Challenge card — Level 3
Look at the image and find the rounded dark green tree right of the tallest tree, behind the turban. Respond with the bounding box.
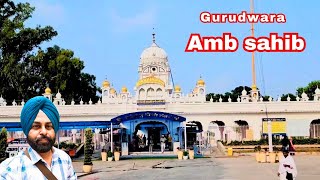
[26,46,99,103]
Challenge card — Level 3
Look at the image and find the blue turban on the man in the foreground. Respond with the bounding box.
[20,96,60,136]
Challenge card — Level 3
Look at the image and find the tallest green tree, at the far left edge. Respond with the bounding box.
[0,0,57,100]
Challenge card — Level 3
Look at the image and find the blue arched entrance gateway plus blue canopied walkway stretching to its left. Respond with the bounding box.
[0,111,203,155]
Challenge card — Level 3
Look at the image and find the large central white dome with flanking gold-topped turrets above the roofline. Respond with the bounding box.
[102,35,206,105]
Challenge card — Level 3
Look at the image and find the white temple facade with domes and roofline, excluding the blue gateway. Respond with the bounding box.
[0,34,320,148]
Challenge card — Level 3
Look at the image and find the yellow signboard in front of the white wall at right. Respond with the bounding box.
[262,118,287,134]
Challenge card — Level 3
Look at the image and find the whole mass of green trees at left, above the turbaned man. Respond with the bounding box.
[0,0,101,105]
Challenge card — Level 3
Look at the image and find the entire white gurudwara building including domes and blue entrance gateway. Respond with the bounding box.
[0,36,320,153]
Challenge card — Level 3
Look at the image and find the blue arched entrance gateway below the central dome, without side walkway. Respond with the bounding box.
[107,111,188,154]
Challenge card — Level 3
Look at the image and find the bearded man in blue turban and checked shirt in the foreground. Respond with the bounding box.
[0,96,77,179]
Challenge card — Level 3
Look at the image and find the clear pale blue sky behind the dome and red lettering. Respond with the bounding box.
[19,0,320,98]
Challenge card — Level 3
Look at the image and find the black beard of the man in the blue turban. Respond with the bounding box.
[27,135,56,153]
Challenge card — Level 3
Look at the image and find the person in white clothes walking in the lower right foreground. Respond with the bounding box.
[278,149,298,180]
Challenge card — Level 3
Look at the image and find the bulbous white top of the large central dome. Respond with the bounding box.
[140,42,168,63]
